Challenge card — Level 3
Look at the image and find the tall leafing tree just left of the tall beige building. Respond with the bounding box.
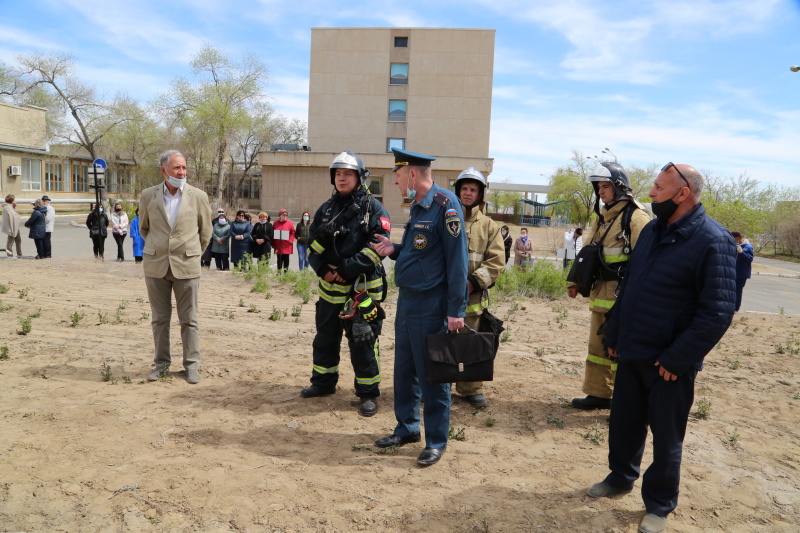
[160,44,267,204]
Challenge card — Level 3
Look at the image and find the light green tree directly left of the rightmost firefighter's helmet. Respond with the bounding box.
[547,149,595,226]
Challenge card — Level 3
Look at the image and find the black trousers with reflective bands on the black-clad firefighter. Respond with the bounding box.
[311,299,383,398]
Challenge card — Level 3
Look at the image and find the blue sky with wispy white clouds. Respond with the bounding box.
[0,0,800,186]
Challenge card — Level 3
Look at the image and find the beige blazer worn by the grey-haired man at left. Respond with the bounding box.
[139,182,211,279]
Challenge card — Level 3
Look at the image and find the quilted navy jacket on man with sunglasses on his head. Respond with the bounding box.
[605,204,736,375]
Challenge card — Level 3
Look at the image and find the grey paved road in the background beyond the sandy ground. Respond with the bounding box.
[6,215,800,315]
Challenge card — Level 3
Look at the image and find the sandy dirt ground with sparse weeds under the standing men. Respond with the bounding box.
[0,235,800,533]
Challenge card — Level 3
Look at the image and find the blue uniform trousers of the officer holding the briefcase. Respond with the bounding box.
[394,288,450,449]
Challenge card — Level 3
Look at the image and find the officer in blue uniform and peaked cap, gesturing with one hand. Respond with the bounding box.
[371,148,467,466]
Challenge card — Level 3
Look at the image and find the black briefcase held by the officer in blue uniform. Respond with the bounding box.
[425,327,495,383]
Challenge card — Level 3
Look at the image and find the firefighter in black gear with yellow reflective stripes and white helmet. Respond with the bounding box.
[300,151,392,416]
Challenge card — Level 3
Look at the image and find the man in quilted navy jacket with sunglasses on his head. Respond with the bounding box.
[588,163,736,533]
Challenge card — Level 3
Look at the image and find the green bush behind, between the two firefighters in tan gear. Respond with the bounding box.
[495,259,567,300]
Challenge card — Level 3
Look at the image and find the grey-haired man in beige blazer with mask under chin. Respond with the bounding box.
[139,150,211,384]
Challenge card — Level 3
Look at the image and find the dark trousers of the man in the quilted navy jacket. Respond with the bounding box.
[605,358,697,516]
